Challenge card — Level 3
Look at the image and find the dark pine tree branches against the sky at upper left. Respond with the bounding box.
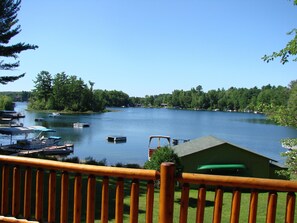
[0,0,38,84]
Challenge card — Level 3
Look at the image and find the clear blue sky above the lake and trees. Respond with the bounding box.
[0,0,297,97]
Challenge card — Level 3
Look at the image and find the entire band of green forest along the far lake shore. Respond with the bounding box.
[0,71,297,123]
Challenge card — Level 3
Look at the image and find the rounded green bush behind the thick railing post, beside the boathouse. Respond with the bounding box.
[144,147,183,175]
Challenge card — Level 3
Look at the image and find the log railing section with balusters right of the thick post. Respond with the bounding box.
[177,173,297,223]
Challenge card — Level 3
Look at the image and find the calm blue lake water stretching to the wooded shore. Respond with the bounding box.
[15,103,297,164]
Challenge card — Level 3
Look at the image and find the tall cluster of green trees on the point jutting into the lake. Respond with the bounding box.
[28,71,129,112]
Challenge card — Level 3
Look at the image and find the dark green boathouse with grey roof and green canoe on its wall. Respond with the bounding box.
[172,136,283,179]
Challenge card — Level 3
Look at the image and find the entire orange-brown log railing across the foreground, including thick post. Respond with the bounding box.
[0,156,297,223]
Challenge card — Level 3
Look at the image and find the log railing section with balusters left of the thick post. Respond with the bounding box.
[0,155,160,223]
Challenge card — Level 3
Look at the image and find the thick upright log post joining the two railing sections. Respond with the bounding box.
[159,162,175,223]
